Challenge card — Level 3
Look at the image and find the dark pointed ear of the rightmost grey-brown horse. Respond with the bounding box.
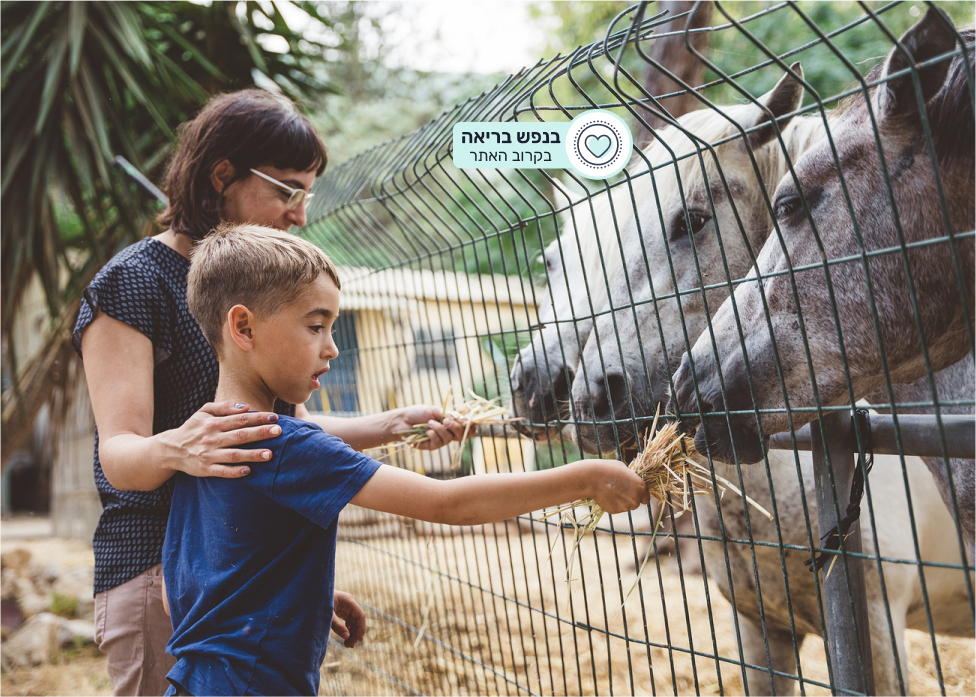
[877,7,956,119]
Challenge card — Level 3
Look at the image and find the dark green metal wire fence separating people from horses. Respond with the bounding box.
[305,3,976,694]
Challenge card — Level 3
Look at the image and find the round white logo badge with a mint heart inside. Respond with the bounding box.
[566,110,634,179]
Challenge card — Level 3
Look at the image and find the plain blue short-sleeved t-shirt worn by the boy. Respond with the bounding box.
[163,416,381,695]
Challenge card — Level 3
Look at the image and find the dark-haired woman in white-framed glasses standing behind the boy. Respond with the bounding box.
[72,90,462,695]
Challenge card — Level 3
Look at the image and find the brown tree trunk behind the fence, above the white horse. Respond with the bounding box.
[634,0,712,148]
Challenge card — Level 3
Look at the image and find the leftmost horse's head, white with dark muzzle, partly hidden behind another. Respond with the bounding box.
[510,182,632,439]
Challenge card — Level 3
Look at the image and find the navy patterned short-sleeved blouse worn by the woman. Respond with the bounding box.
[71,238,295,593]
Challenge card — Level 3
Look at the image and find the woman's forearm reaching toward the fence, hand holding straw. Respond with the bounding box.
[295,404,464,450]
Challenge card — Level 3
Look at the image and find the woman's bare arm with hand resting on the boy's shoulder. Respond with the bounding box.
[81,313,280,491]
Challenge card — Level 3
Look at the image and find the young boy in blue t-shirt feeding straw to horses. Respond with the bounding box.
[163,226,648,695]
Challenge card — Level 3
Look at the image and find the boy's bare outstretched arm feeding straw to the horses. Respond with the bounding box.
[352,460,650,525]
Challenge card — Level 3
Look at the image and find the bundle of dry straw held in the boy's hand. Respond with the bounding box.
[542,408,773,602]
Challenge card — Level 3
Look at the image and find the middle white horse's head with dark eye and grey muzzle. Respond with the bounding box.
[573,64,813,453]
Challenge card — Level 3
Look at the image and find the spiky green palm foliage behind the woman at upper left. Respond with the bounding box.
[0,2,343,468]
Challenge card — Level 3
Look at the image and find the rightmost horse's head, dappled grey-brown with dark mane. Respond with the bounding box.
[675,10,976,462]
